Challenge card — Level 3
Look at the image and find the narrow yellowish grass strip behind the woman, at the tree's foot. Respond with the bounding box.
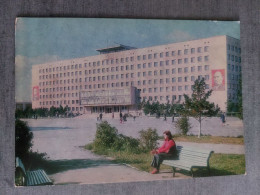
[173,134,244,145]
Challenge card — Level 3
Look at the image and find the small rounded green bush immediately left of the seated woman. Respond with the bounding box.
[139,128,159,151]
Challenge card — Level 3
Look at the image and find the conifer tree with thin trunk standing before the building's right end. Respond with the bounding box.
[184,78,220,138]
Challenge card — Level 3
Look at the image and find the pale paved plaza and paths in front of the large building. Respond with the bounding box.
[23,115,244,184]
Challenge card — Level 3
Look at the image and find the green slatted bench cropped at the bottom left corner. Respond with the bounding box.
[15,157,53,186]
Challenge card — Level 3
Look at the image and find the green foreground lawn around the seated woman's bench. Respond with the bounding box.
[85,145,245,177]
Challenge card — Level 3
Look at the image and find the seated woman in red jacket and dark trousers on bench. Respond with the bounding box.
[151,131,177,174]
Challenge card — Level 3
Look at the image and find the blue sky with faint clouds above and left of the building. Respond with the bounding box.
[15,18,240,102]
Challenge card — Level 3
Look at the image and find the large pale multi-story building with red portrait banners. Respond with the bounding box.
[32,35,241,114]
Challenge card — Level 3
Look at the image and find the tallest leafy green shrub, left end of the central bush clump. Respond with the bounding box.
[94,121,118,150]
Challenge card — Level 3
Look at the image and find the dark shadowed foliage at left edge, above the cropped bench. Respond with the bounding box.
[15,119,33,161]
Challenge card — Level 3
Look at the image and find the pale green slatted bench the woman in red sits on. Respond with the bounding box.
[162,146,213,177]
